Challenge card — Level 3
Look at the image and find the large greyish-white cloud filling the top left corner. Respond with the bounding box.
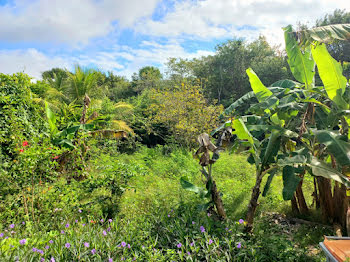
[0,0,159,44]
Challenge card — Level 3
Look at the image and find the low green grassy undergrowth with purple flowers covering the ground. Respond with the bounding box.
[0,145,327,261]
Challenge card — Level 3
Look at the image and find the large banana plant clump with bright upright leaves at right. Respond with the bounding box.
[213,25,350,231]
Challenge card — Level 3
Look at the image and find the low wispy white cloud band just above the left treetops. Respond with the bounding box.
[0,41,214,79]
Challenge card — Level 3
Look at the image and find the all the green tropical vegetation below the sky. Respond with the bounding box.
[0,10,350,261]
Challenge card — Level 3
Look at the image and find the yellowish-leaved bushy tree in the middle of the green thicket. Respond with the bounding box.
[150,83,222,147]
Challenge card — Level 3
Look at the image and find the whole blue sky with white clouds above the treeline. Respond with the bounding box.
[0,0,350,79]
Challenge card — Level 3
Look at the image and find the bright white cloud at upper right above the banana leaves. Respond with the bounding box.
[135,0,350,44]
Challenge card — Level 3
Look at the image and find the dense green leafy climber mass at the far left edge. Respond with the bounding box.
[0,73,47,174]
